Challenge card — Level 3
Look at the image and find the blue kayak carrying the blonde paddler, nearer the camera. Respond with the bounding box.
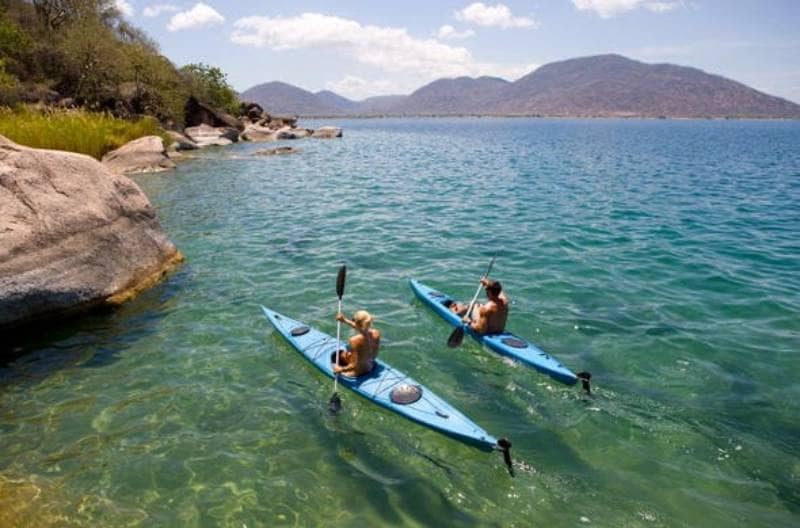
[261,306,503,450]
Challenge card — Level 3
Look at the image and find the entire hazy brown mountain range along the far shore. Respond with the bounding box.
[240,54,800,119]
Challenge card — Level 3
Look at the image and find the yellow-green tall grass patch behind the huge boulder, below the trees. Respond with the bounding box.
[0,107,166,159]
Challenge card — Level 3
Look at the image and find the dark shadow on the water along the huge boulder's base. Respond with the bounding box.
[0,268,189,386]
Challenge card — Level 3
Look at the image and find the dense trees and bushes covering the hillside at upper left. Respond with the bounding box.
[0,0,240,128]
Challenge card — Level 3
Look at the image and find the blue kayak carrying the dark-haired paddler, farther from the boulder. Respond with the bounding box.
[410,279,588,390]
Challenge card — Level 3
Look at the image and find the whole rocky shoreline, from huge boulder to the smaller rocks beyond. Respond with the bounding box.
[0,103,342,331]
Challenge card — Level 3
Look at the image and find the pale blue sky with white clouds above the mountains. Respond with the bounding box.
[117,0,800,103]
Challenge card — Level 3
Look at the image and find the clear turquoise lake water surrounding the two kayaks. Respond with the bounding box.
[0,119,800,527]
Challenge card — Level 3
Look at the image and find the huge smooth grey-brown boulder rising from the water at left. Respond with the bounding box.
[0,136,183,328]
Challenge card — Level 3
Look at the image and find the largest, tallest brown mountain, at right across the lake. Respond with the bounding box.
[490,55,800,117]
